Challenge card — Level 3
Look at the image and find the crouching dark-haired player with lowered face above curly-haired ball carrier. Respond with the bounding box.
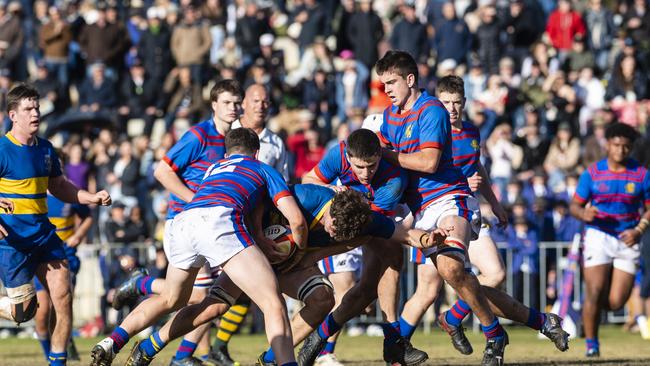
[303,129,428,365]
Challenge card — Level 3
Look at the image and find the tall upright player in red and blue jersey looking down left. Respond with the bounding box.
[376,51,508,365]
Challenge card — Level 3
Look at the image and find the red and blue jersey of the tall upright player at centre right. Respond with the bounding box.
[379,91,471,213]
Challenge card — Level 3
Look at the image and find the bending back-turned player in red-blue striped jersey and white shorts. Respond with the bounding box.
[121,128,307,365]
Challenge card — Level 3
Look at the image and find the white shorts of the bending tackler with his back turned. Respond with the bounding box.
[163,206,254,273]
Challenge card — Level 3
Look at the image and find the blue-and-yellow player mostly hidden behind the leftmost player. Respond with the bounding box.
[34,194,93,361]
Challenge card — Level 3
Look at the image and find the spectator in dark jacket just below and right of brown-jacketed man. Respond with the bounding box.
[117,59,162,136]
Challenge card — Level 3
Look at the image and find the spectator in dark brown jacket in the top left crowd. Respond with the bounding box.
[79,6,129,80]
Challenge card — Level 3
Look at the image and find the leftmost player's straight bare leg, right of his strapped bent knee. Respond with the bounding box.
[36,260,72,365]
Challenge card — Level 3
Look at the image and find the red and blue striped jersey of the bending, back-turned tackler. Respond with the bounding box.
[184,155,291,214]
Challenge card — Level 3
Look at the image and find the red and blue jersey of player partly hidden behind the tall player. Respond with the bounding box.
[451,121,481,177]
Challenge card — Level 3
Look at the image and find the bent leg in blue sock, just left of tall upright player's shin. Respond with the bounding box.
[399,252,442,339]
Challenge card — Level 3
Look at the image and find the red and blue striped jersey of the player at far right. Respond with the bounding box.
[574,159,650,236]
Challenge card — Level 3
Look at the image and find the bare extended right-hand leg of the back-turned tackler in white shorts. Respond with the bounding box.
[223,245,295,365]
